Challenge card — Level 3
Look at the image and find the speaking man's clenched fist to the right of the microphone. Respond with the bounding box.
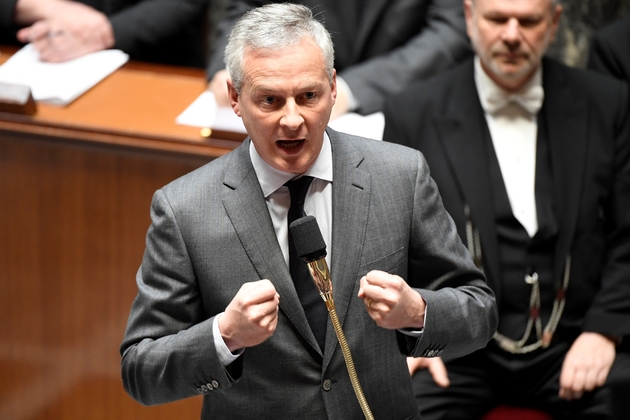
[359,270,426,329]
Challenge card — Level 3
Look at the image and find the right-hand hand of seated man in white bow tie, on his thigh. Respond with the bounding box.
[559,332,616,401]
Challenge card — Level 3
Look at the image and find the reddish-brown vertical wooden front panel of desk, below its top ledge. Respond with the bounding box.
[0,131,210,420]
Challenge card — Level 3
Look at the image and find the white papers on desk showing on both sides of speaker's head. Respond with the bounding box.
[175,91,385,140]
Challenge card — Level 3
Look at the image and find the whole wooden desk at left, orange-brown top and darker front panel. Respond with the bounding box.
[0,50,242,420]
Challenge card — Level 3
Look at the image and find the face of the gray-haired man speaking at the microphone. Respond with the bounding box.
[228,38,337,174]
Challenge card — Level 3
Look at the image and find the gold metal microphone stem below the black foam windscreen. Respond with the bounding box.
[308,258,374,420]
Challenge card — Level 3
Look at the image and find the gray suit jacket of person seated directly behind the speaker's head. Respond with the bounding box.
[208,0,472,114]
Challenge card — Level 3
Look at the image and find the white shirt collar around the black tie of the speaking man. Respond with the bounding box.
[249,132,333,198]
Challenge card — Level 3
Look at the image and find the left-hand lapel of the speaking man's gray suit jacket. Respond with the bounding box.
[222,141,319,351]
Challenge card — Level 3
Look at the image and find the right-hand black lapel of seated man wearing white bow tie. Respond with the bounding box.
[539,60,589,278]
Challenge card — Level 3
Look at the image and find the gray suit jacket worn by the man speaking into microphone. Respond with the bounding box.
[121,130,497,419]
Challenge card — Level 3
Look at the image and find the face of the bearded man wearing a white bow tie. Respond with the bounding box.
[464,0,562,90]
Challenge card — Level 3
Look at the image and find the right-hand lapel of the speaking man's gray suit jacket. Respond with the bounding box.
[324,129,372,368]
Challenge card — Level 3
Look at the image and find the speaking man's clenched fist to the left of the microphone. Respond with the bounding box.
[219,280,280,353]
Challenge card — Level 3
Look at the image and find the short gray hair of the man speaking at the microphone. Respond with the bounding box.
[225,3,335,94]
